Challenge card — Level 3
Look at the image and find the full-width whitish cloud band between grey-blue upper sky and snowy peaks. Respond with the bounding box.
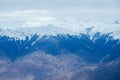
[0,9,120,28]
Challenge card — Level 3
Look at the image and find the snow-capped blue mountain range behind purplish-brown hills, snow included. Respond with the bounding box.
[0,18,120,62]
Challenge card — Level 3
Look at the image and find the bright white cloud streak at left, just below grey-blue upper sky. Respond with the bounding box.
[0,10,51,21]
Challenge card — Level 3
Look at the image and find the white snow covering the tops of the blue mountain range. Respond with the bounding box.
[0,17,120,40]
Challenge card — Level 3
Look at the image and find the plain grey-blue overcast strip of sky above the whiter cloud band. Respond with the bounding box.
[0,0,120,11]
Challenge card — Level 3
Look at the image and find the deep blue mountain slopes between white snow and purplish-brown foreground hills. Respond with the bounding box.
[0,33,120,62]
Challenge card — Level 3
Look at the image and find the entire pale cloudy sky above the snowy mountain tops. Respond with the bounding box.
[0,0,120,27]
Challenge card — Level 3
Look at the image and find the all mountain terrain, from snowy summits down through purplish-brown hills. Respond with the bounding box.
[0,18,120,80]
